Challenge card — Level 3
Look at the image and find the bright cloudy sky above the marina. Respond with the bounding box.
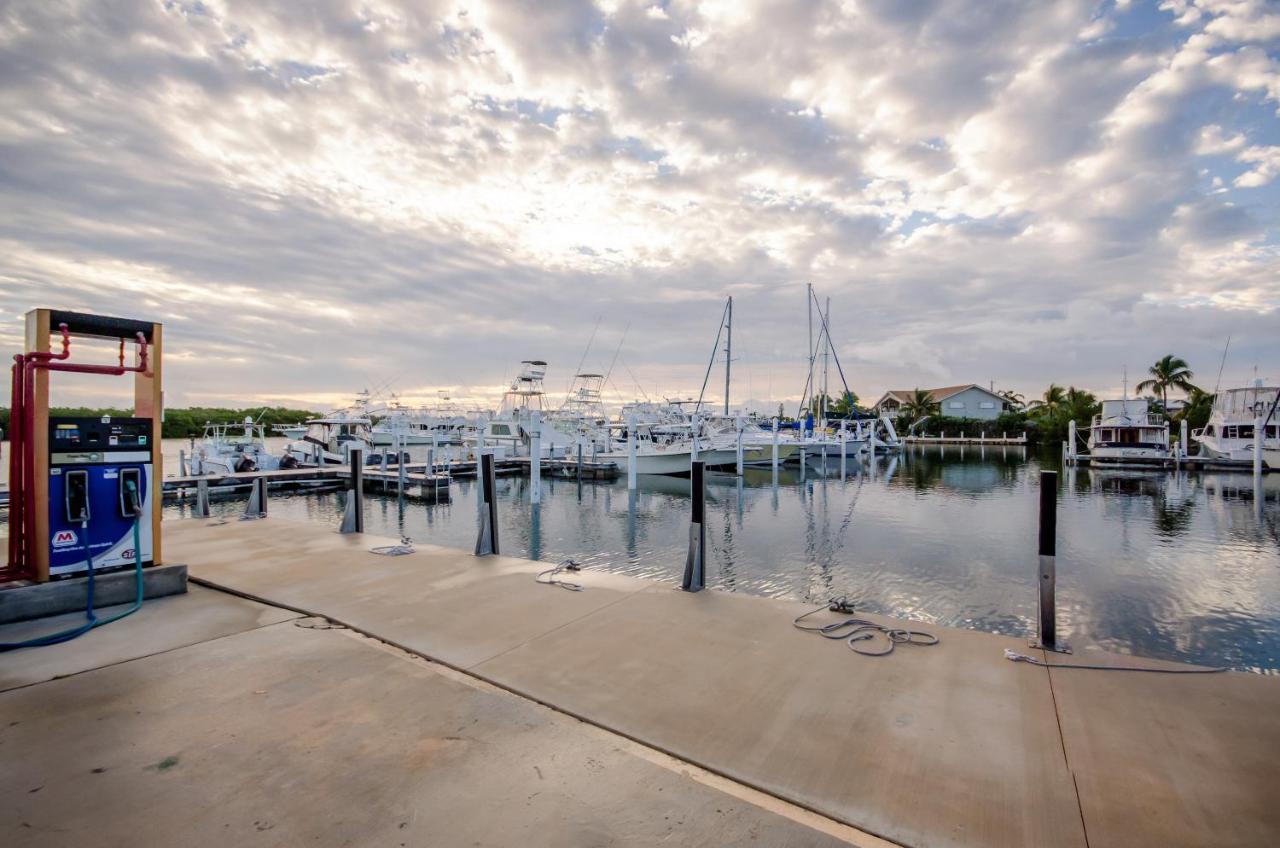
[0,0,1280,409]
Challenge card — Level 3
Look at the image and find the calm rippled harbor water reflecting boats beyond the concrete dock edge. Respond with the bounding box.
[157,444,1280,671]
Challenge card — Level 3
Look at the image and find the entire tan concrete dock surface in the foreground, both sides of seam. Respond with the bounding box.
[0,518,1280,848]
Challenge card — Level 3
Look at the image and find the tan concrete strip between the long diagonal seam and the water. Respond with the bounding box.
[120,518,1280,848]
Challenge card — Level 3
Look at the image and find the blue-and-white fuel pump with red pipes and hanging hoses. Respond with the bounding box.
[0,309,163,649]
